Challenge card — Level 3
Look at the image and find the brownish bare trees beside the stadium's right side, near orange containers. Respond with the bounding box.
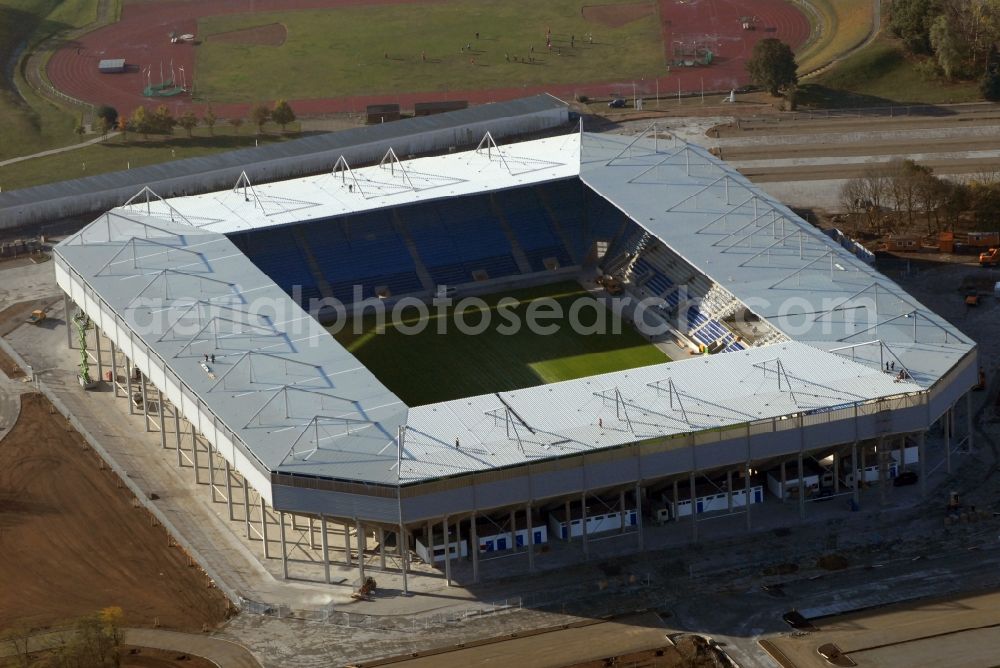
[840,160,1000,235]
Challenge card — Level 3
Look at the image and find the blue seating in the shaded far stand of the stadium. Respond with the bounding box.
[232,179,640,305]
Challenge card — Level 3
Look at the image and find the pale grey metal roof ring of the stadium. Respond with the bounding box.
[56,132,975,485]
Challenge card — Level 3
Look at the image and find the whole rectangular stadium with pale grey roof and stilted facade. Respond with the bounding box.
[54,100,978,591]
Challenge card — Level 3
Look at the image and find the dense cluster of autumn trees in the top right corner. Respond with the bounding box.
[889,0,1000,94]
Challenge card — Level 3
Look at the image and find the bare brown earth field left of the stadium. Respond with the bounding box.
[0,394,228,631]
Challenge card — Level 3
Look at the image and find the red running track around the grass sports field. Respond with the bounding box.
[47,0,810,118]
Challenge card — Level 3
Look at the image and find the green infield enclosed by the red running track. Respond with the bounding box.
[197,0,664,102]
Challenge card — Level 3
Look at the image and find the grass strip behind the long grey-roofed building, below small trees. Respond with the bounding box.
[0,125,296,190]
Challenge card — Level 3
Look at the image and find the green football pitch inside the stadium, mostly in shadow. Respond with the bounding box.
[334,283,669,406]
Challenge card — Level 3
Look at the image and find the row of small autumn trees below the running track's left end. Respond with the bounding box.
[96,100,296,138]
